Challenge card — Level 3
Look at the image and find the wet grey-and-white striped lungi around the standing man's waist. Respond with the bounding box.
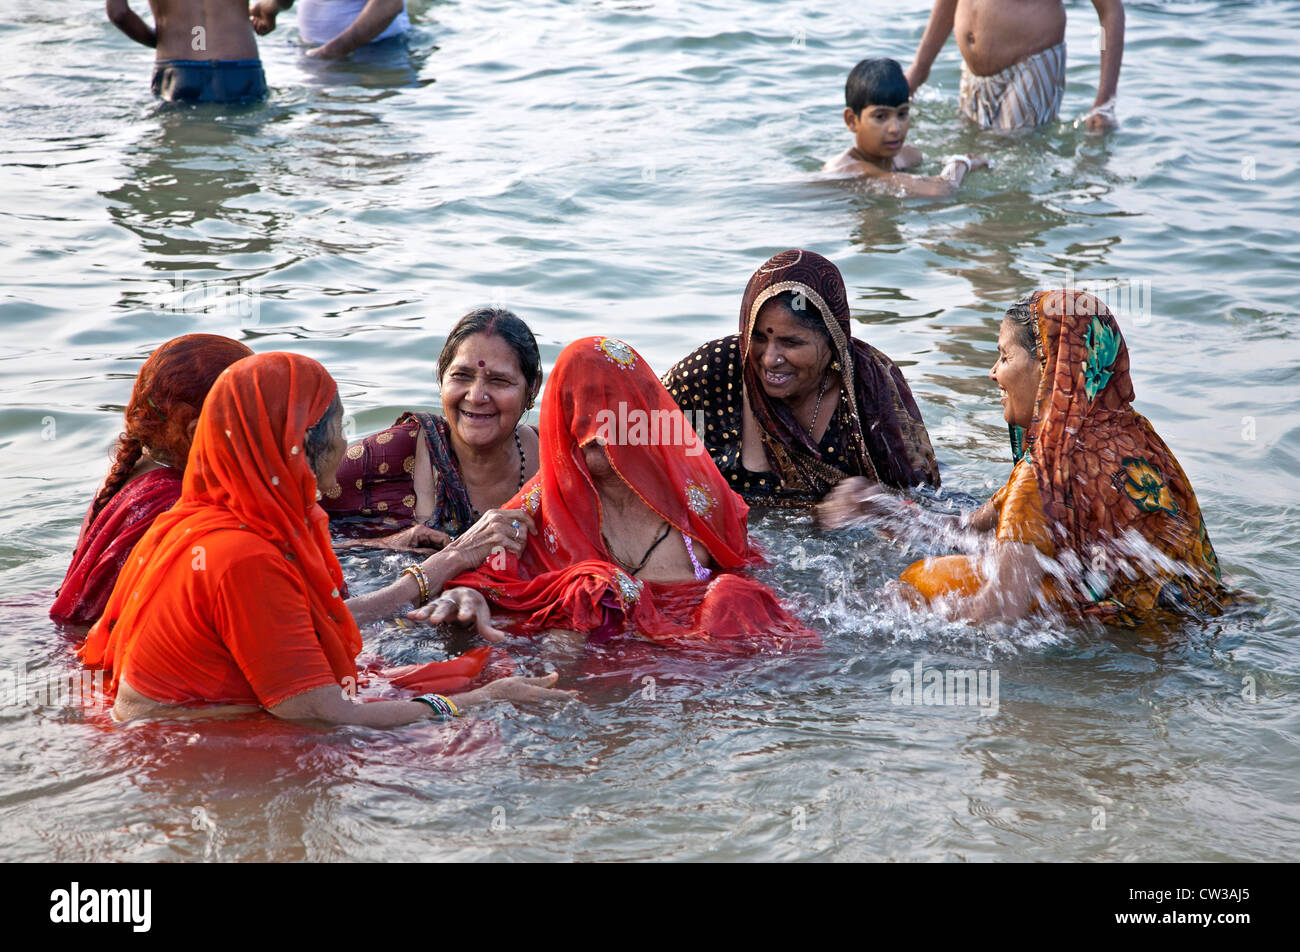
[961,40,1065,130]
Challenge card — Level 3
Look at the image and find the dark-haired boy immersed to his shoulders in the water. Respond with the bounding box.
[822,59,988,198]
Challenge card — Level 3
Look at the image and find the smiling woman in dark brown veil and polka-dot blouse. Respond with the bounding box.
[663,250,939,506]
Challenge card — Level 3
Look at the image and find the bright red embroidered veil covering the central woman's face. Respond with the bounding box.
[447,337,815,655]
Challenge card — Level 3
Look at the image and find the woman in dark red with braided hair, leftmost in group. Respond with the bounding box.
[49,334,252,626]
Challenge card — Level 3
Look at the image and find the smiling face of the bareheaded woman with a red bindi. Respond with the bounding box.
[442,334,529,449]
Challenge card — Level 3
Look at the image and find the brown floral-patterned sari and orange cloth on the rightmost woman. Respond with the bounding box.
[902,291,1231,627]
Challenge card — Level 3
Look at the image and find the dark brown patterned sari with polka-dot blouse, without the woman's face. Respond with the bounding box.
[663,250,940,506]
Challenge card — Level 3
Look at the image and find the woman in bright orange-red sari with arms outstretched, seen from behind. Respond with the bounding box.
[79,354,567,727]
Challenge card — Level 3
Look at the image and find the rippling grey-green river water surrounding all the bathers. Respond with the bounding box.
[0,0,1300,861]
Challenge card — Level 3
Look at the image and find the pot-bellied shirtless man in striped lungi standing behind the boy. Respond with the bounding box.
[907,0,1125,133]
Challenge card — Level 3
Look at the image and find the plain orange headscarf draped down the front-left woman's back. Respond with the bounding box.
[79,352,361,689]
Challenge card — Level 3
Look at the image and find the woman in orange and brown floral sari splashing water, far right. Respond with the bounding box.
[823,290,1231,627]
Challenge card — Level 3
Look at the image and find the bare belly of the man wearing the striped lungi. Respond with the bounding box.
[953,0,1065,75]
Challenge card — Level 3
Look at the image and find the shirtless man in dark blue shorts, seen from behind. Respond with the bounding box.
[104,0,294,103]
